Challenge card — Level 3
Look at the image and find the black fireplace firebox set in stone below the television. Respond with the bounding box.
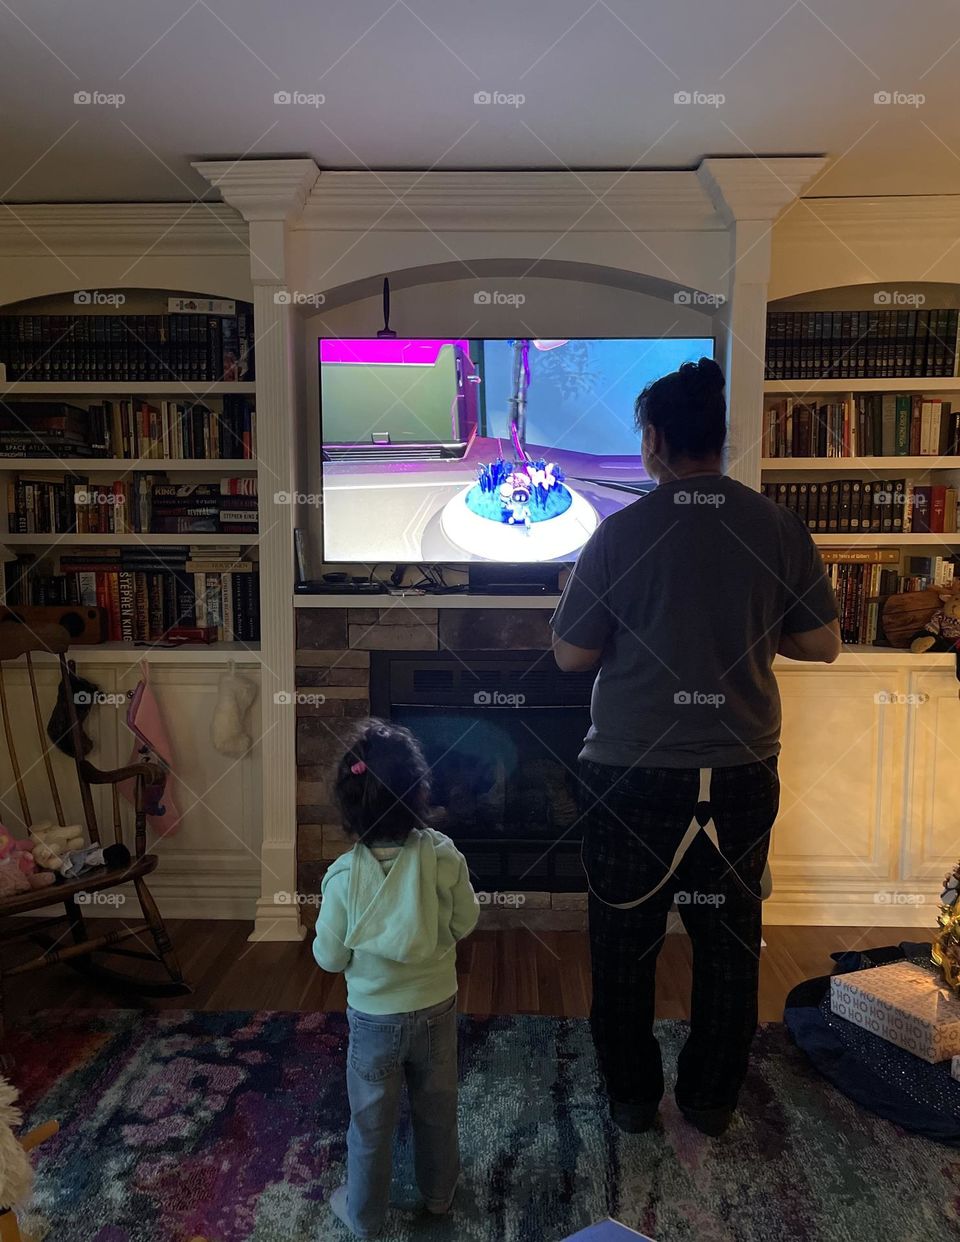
[370,651,594,893]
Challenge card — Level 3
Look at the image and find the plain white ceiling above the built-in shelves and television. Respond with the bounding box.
[0,0,960,202]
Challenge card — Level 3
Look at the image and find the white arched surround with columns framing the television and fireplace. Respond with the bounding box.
[194,156,825,939]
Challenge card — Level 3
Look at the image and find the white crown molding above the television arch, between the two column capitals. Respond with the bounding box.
[296,171,725,232]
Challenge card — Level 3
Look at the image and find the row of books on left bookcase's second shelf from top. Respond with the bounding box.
[0,394,257,461]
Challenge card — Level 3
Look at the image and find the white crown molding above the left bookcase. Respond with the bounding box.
[0,202,247,258]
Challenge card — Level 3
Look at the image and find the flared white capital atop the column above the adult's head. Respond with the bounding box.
[697,155,827,225]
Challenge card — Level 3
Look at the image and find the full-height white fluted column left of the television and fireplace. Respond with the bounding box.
[194,160,318,940]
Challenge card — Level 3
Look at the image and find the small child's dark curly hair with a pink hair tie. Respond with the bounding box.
[334,719,430,845]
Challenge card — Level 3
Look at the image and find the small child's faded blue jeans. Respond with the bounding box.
[337,995,460,1237]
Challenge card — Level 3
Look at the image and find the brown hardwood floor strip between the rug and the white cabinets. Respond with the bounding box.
[7,919,925,1022]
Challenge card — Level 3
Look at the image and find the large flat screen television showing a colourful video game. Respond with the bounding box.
[319,337,714,564]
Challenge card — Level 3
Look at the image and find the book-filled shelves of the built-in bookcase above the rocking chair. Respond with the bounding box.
[0,291,260,658]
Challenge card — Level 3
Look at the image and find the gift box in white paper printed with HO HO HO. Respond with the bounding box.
[830,961,960,1062]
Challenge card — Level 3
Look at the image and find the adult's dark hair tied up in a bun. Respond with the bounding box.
[633,358,727,458]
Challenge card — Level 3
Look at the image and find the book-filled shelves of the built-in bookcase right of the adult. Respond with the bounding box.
[760,291,960,650]
